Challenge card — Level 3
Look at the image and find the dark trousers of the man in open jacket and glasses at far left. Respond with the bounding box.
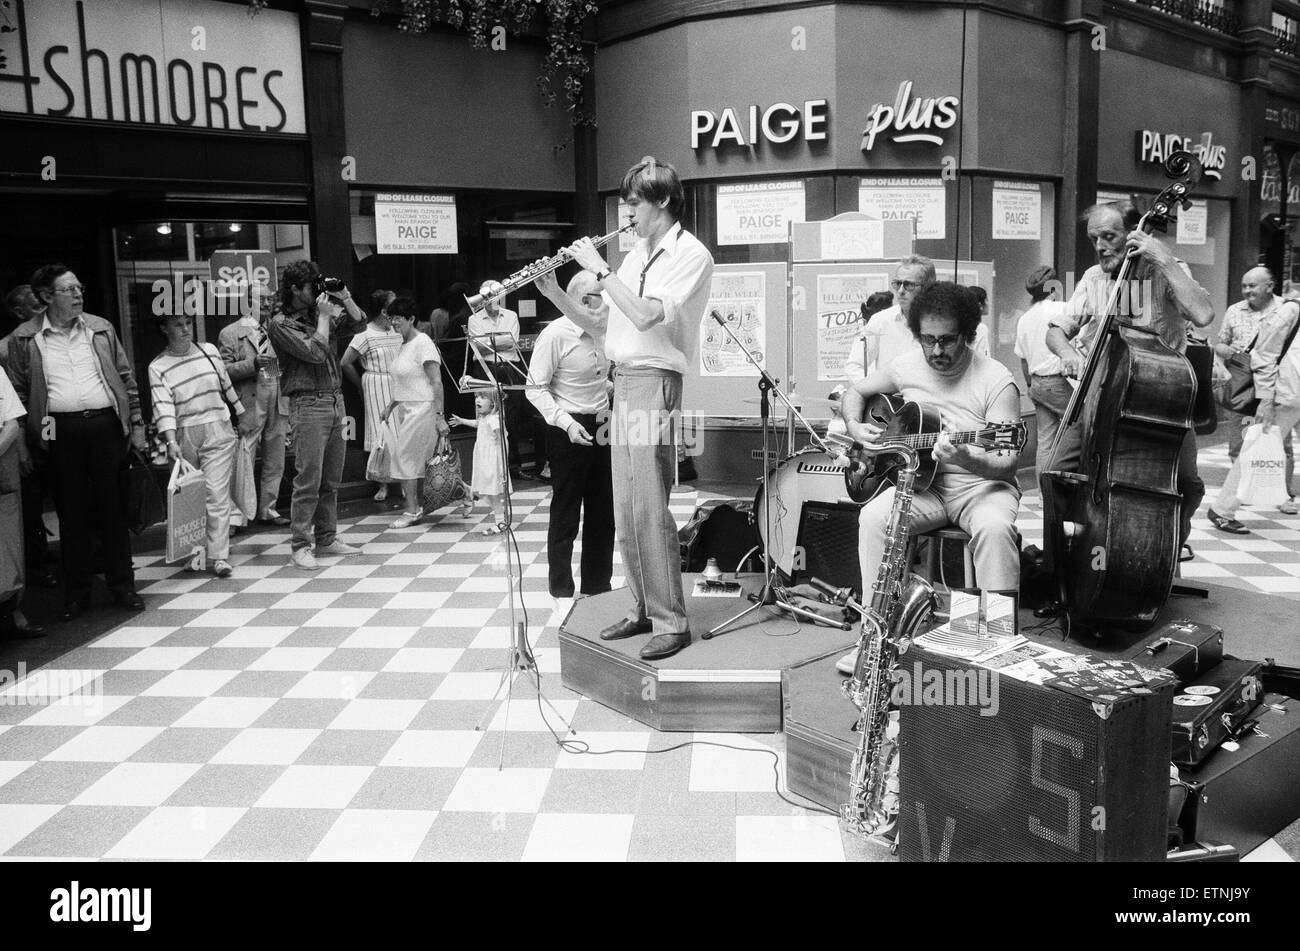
[49,409,135,602]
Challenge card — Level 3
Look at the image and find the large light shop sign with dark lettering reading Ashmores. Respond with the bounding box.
[0,0,307,134]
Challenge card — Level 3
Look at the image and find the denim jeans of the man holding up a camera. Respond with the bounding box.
[289,392,345,551]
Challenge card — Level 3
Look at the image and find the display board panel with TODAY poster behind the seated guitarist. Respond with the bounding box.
[790,259,993,420]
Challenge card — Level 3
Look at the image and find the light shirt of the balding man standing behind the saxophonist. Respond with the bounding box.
[525,317,610,431]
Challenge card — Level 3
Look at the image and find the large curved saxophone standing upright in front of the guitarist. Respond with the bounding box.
[840,446,935,835]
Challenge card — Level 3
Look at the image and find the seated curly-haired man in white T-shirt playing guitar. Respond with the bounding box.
[844,282,1021,596]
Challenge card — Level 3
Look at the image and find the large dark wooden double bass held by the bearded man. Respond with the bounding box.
[1040,152,1201,634]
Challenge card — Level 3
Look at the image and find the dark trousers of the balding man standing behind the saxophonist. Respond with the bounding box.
[546,413,614,598]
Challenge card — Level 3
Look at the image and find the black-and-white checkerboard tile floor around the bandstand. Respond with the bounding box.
[0,448,1300,861]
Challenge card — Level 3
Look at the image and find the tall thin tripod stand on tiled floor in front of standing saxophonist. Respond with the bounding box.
[462,334,573,770]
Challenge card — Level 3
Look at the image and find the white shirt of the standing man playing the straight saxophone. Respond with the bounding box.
[605,223,714,373]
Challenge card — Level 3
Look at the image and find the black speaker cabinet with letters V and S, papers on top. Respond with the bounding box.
[896,647,1174,861]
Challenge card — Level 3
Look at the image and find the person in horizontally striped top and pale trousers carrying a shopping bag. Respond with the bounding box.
[150,316,256,578]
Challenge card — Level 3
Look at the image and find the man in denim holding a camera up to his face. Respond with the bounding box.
[267,261,365,572]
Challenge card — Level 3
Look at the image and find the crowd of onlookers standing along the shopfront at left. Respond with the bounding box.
[0,261,535,638]
